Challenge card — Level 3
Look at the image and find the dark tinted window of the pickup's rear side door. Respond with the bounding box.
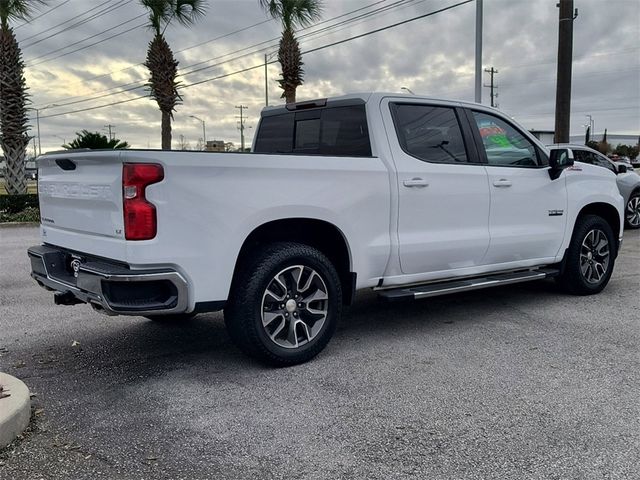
[391,104,467,163]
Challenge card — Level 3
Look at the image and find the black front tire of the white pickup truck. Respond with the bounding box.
[557,215,617,295]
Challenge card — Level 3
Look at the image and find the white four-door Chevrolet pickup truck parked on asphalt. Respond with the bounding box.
[29,93,623,365]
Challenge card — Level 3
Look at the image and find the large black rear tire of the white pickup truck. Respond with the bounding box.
[224,242,342,367]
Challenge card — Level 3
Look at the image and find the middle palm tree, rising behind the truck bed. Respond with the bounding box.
[140,0,205,150]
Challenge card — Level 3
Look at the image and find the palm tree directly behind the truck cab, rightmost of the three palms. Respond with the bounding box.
[260,0,322,103]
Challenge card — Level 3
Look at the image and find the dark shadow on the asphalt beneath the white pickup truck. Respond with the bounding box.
[11,281,558,382]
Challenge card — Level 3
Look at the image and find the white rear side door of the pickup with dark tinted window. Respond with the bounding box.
[382,100,489,274]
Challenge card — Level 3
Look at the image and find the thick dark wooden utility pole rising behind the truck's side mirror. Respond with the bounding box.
[554,0,578,143]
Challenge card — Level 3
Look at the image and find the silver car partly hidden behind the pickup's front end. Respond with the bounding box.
[548,143,640,228]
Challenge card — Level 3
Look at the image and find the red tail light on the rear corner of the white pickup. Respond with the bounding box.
[122,163,164,240]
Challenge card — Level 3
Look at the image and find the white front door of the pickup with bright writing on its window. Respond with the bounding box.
[467,110,567,265]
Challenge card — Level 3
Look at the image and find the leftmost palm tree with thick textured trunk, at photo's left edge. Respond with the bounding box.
[0,0,46,195]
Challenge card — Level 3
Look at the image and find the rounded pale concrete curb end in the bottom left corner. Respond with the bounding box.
[0,372,31,448]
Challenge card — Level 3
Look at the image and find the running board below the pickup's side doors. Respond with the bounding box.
[378,268,560,302]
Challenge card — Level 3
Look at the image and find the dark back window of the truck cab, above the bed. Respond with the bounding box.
[255,105,371,157]
